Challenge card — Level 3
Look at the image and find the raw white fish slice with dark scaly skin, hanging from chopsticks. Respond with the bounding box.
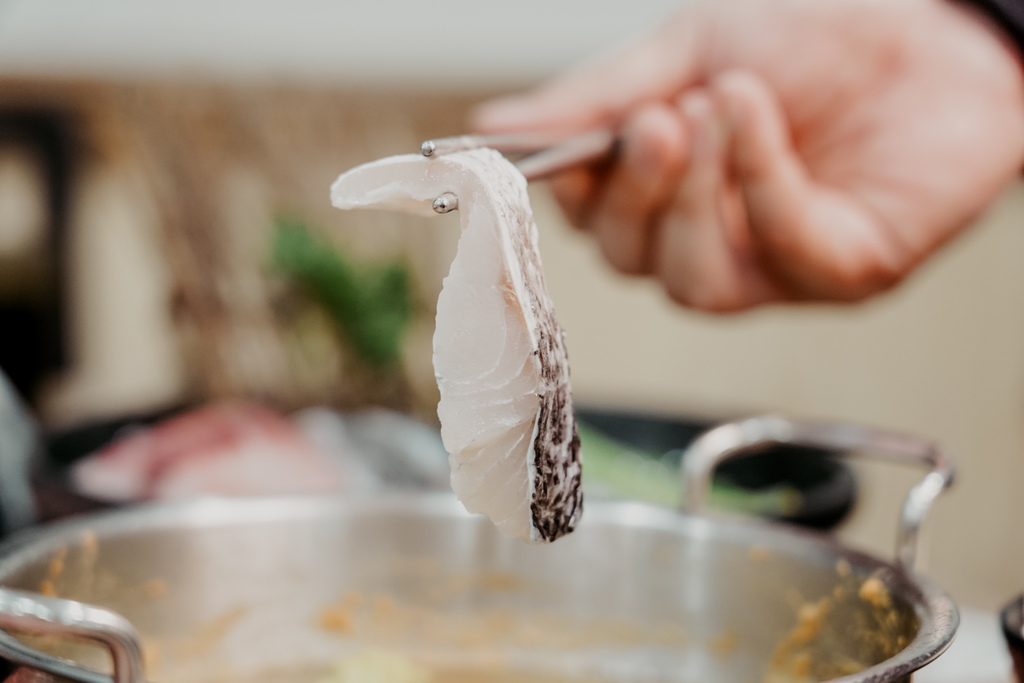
[331,150,583,543]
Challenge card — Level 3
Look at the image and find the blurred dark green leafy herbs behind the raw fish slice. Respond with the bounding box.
[272,218,412,368]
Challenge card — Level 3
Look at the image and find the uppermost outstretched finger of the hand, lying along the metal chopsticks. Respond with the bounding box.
[472,6,706,132]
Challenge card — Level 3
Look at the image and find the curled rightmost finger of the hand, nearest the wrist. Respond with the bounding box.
[713,70,902,300]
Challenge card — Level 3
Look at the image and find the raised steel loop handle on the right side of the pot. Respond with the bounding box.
[681,416,955,571]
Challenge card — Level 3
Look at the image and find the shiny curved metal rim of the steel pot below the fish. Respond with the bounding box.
[0,492,959,683]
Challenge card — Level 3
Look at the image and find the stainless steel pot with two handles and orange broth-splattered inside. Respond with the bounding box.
[0,417,958,683]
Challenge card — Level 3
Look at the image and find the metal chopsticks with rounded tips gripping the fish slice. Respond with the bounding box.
[420,128,617,213]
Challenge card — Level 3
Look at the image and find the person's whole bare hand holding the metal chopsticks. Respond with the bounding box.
[475,0,1024,311]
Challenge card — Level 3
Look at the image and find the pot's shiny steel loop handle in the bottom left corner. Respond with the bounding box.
[0,588,144,683]
